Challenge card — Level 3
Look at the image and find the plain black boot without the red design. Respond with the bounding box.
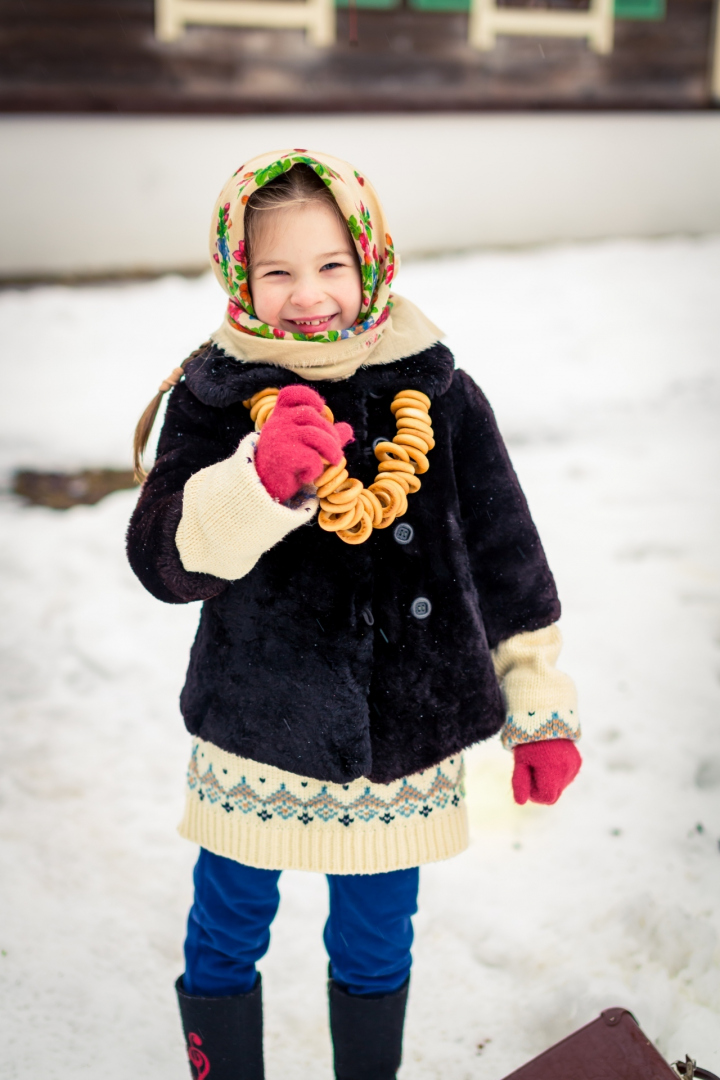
[328,978,410,1080]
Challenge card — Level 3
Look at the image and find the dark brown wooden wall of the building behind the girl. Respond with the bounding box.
[0,0,711,113]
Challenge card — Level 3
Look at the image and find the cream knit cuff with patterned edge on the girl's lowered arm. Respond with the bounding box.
[492,623,580,750]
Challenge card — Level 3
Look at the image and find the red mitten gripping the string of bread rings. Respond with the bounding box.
[255,386,353,502]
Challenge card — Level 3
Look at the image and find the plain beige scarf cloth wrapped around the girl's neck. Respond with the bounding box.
[212,294,444,381]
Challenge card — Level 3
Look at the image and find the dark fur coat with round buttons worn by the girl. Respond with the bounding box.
[127,345,560,783]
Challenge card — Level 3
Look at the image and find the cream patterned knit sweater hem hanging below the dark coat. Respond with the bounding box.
[180,739,467,874]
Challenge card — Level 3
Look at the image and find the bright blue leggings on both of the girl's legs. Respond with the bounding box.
[182,848,420,997]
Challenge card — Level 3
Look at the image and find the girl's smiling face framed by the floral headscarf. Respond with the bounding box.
[250,202,363,334]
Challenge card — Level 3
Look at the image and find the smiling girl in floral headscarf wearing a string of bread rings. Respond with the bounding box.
[128,150,581,1080]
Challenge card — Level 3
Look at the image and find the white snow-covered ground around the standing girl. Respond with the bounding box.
[0,238,720,1080]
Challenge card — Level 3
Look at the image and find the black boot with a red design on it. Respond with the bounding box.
[175,975,264,1080]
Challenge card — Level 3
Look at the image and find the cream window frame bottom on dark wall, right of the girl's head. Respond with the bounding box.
[467,0,615,55]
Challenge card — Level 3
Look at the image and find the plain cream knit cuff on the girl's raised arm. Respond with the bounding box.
[175,432,317,581]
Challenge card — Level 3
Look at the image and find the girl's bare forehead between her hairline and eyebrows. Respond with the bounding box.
[254,201,353,262]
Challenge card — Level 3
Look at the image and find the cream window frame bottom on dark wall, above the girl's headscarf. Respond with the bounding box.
[155,0,336,49]
